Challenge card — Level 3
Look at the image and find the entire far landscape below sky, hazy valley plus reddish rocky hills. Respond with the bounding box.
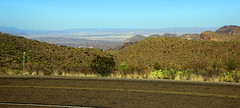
[3,25,240,50]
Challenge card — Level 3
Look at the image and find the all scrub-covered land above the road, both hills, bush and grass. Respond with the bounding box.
[0,26,240,82]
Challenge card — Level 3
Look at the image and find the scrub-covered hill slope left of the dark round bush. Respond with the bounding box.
[0,33,112,74]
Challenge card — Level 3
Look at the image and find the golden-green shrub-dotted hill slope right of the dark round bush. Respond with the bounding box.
[115,37,240,70]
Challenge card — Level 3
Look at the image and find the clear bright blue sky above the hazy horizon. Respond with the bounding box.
[0,0,240,30]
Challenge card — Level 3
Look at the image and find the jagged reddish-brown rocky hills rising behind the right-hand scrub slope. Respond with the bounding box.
[108,25,240,50]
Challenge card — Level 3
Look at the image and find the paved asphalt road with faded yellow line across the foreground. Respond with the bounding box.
[0,77,240,108]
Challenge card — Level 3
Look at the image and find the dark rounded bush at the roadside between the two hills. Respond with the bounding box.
[91,55,116,77]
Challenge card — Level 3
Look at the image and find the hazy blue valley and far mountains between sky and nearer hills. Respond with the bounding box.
[0,27,217,49]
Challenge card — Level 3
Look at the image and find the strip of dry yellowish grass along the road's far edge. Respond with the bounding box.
[0,69,240,82]
